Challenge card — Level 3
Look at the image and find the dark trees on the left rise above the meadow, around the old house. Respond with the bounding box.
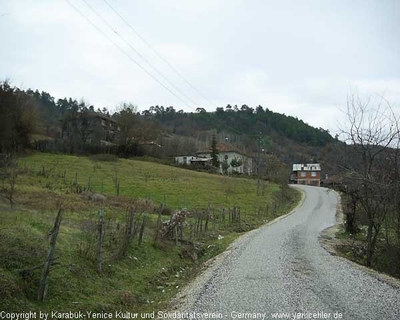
[0,81,160,156]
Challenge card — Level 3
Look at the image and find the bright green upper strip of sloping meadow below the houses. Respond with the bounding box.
[20,154,278,211]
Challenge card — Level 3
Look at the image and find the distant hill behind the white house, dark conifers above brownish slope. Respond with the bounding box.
[141,105,337,164]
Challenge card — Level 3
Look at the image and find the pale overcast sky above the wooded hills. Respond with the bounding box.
[0,0,400,134]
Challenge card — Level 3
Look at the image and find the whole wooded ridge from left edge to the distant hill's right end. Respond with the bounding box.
[0,81,336,163]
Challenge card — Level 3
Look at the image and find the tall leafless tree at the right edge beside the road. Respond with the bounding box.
[340,95,399,266]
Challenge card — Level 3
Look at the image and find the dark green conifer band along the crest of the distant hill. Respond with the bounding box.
[141,104,335,147]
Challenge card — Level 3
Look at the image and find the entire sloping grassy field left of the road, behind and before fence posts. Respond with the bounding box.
[0,153,299,312]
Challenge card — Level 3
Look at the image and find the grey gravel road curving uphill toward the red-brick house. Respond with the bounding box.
[174,186,400,320]
